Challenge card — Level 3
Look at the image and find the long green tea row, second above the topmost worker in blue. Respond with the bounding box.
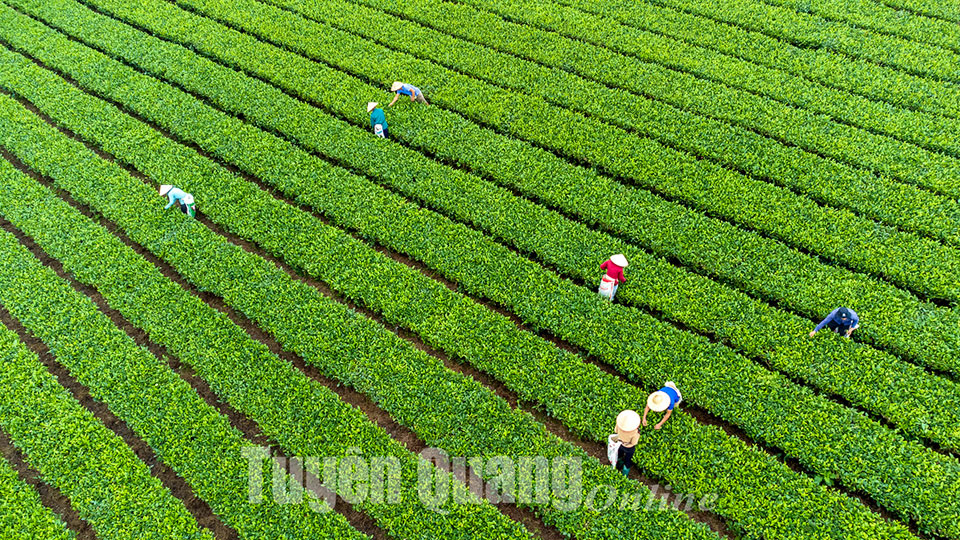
[270,0,960,251]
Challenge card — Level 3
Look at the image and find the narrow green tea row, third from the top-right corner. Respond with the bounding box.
[648,0,960,82]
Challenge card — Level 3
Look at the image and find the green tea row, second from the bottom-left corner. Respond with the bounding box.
[0,318,213,540]
